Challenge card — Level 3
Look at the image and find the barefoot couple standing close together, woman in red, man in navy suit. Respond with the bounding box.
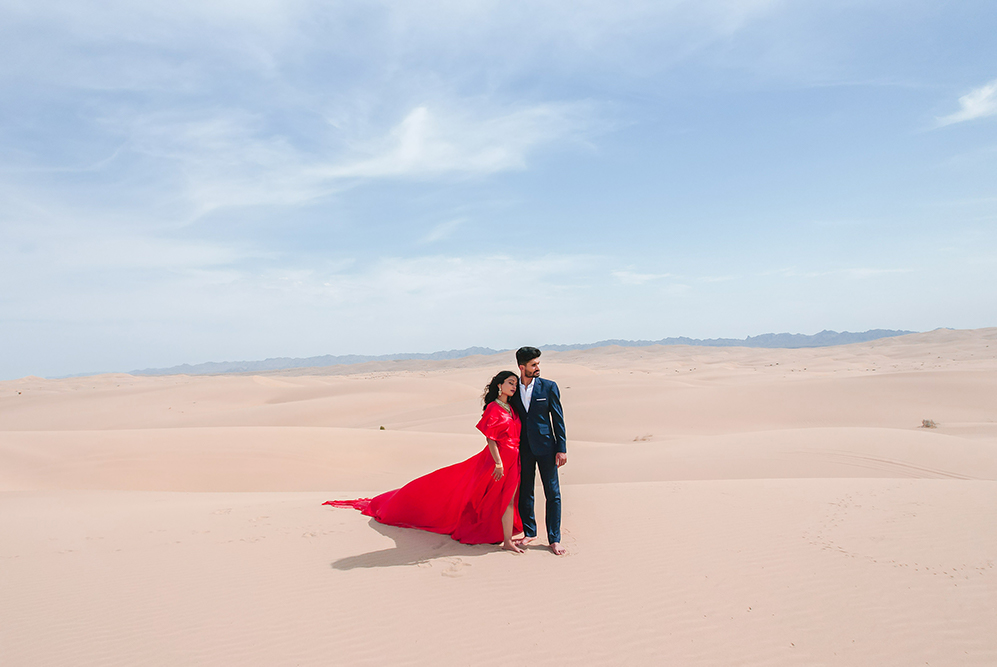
[324,347,568,556]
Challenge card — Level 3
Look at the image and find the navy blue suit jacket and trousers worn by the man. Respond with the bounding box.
[512,378,568,544]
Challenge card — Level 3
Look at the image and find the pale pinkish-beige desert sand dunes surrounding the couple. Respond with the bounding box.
[0,329,997,667]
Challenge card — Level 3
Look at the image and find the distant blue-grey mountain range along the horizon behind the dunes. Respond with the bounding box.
[131,329,917,375]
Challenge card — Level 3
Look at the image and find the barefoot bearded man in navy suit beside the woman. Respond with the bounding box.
[512,347,568,556]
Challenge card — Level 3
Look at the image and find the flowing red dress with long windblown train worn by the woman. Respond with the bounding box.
[322,402,523,544]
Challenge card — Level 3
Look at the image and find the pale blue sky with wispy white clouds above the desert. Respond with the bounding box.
[0,0,997,380]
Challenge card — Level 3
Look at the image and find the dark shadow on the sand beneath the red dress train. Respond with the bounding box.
[332,519,499,570]
